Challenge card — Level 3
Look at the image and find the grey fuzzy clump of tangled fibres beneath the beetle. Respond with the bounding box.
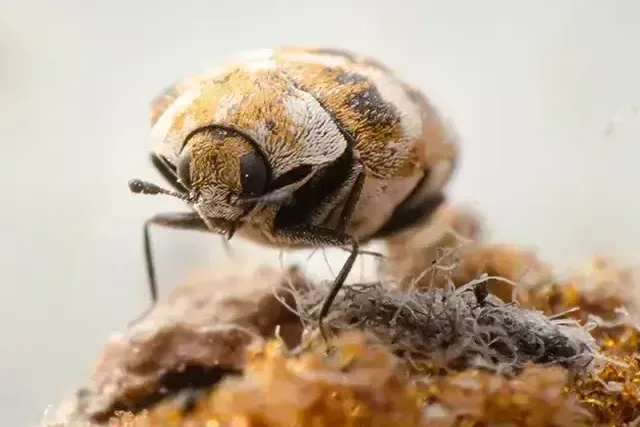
[295,279,597,372]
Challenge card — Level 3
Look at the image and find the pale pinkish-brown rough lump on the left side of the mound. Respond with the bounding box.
[42,268,306,421]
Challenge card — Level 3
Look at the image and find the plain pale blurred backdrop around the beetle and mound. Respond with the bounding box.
[0,0,640,426]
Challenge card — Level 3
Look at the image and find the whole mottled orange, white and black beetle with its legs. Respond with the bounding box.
[130,43,459,338]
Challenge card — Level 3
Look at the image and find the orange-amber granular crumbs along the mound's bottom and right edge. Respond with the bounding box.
[104,252,640,427]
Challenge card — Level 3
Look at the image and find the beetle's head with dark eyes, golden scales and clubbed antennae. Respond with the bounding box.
[129,127,308,239]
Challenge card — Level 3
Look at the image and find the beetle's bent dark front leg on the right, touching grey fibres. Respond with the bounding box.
[274,226,359,342]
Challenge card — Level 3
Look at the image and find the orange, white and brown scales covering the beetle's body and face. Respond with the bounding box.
[152,46,459,243]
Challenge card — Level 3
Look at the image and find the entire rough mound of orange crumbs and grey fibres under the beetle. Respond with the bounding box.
[40,234,640,427]
